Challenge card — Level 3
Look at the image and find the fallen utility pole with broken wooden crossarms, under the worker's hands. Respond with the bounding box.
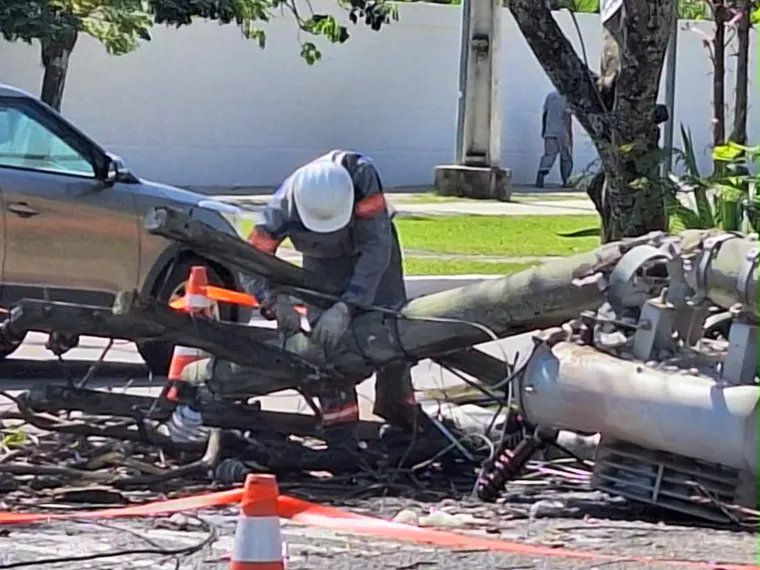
[5,208,757,393]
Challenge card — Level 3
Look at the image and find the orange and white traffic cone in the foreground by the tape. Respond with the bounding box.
[230,474,285,570]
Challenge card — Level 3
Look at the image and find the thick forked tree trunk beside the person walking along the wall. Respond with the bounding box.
[509,0,674,241]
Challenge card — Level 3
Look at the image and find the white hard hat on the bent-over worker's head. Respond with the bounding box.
[289,159,354,234]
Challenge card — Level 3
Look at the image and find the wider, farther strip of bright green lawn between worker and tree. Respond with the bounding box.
[396,216,599,257]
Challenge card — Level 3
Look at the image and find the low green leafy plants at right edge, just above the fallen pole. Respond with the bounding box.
[665,125,760,232]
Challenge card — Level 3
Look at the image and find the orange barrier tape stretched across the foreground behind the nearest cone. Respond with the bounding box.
[0,489,760,570]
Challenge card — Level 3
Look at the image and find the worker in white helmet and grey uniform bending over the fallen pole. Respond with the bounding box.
[248,150,422,444]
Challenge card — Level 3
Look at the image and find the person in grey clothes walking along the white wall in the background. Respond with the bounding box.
[536,87,573,188]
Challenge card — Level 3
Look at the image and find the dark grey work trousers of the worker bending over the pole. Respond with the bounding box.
[303,223,414,427]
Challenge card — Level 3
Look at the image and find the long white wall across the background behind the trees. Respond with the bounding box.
[0,0,760,186]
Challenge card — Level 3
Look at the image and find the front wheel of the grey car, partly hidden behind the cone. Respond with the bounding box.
[137,257,237,376]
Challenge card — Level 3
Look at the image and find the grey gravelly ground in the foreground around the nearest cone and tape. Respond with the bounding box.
[0,485,757,570]
